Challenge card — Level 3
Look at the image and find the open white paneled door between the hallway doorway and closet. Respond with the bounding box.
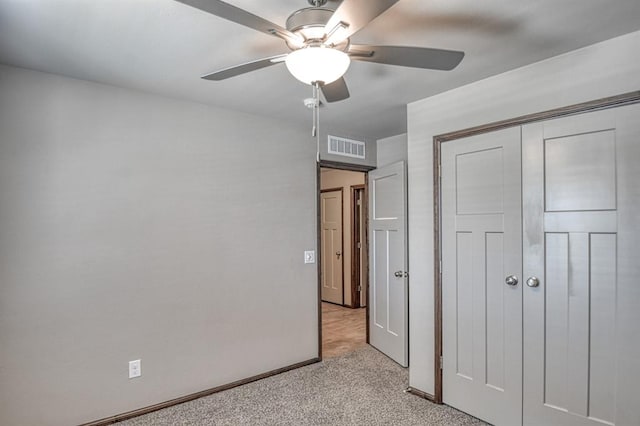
[369,161,409,367]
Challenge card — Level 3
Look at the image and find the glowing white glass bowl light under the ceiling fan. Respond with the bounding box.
[285,46,351,84]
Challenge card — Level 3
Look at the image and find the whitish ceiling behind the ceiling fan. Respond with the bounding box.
[0,0,640,139]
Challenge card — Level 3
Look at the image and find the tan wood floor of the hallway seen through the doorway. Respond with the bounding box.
[322,302,367,358]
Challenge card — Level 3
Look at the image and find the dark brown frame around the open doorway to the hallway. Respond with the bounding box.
[316,160,375,360]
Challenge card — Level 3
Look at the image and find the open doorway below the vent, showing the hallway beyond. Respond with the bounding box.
[318,164,369,358]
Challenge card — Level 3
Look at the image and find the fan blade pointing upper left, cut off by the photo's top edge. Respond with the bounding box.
[176,0,304,43]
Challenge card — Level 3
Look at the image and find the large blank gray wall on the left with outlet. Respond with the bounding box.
[0,66,318,426]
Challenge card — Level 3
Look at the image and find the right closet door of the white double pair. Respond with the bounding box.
[523,105,640,426]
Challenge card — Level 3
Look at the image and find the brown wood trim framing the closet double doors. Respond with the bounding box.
[430,91,640,404]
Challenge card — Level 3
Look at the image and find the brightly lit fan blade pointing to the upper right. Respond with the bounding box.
[324,0,398,45]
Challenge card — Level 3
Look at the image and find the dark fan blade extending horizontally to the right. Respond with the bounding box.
[349,44,464,71]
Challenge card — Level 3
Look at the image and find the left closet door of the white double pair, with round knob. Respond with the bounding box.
[441,128,522,425]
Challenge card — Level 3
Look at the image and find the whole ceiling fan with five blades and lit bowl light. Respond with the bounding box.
[177,0,464,102]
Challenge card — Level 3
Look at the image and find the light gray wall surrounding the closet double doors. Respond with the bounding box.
[408,32,640,393]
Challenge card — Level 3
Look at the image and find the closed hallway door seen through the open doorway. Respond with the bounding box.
[320,190,344,305]
